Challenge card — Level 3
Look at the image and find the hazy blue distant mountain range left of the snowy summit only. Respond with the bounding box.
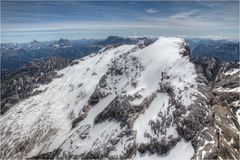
[1,36,154,76]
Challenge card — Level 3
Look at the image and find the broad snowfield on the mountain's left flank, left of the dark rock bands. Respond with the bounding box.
[1,43,134,158]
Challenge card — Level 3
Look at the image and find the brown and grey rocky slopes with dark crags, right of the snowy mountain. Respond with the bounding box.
[194,58,240,159]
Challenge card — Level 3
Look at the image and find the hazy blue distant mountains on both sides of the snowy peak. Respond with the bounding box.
[1,36,239,77]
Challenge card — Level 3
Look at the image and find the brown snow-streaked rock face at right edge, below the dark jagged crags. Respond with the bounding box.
[213,62,240,159]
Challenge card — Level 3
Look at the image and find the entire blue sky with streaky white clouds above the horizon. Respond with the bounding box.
[1,0,239,43]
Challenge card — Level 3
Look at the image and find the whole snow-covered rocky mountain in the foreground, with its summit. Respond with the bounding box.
[0,37,216,159]
